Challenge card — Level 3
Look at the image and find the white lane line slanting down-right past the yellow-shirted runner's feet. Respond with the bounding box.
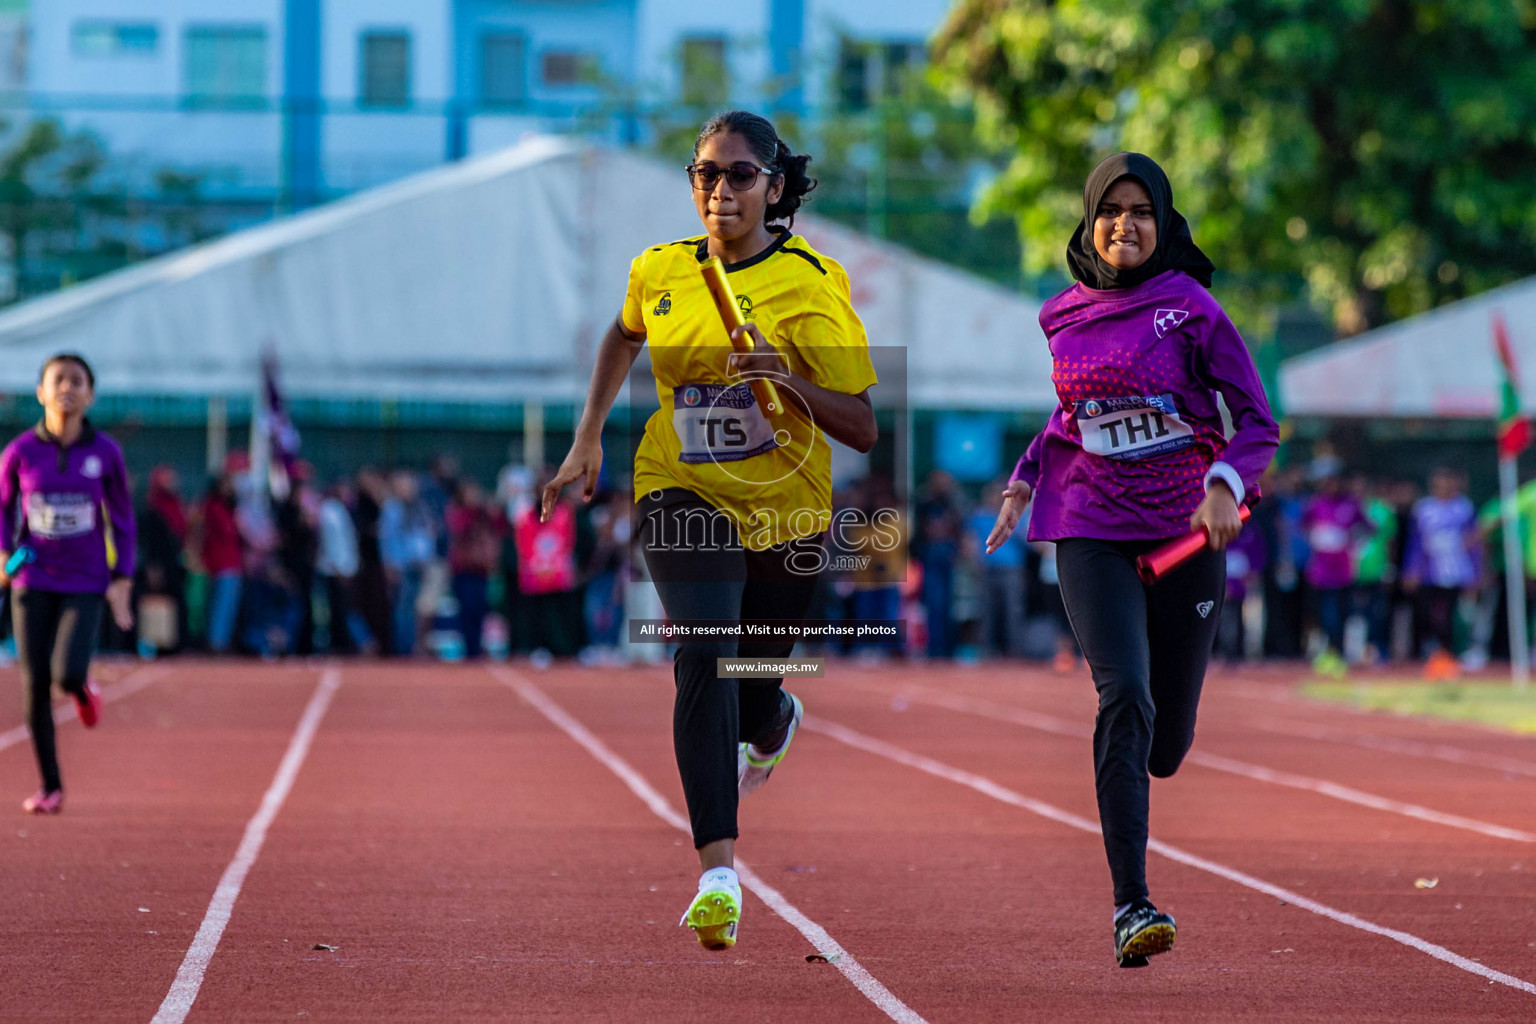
[492,666,928,1024]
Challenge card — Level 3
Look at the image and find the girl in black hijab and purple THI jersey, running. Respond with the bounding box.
[988,154,1279,967]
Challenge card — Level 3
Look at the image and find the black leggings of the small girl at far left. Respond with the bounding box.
[11,590,101,792]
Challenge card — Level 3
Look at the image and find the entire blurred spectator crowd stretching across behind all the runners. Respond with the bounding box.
[33,445,1536,676]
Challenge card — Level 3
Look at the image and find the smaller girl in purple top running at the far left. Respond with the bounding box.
[0,353,135,814]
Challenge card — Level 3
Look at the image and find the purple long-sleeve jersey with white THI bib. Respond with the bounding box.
[1014,270,1279,540]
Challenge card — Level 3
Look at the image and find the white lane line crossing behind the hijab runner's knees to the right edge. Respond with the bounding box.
[902,686,1536,843]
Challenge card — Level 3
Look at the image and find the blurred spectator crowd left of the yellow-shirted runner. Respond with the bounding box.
[94,453,631,660]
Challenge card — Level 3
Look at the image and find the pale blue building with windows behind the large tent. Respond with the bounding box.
[24,0,948,206]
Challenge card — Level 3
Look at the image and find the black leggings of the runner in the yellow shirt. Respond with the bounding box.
[639,488,823,849]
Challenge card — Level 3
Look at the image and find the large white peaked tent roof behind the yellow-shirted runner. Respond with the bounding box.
[0,138,1054,408]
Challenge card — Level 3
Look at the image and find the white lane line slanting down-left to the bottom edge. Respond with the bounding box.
[151,668,341,1024]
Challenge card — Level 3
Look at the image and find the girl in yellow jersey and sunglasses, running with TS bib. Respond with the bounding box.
[542,111,876,949]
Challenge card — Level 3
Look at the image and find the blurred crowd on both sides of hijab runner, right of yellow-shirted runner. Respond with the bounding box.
[865,444,1536,677]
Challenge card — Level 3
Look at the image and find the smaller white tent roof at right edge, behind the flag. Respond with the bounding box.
[1279,278,1536,418]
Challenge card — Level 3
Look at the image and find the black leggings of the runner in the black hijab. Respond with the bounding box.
[1057,539,1227,906]
